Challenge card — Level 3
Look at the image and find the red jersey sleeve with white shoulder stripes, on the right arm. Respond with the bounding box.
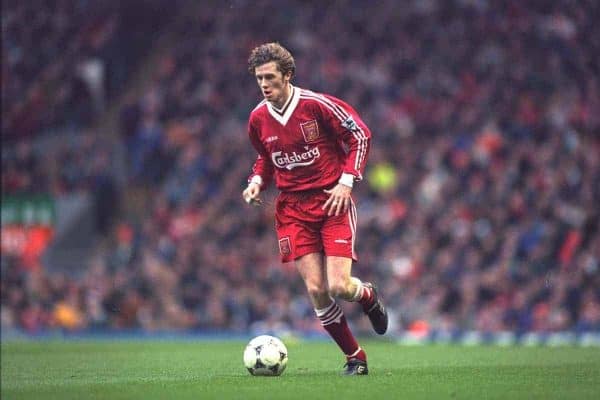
[317,96,371,181]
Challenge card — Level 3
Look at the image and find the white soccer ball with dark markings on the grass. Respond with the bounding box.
[244,335,287,376]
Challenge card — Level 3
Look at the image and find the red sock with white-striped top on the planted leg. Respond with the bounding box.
[316,301,367,361]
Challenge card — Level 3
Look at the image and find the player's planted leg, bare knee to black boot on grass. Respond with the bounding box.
[295,253,368,375]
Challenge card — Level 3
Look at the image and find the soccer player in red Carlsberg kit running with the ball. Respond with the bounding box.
[242,43,388,375]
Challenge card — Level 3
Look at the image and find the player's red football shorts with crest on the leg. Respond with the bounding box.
[275,190,357,263]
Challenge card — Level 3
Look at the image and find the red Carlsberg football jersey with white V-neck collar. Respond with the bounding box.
[248,86,371,192]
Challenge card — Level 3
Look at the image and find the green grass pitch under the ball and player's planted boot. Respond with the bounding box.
[0,341,600,400]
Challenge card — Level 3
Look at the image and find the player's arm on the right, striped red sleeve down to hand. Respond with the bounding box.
[319,98,371,215]
